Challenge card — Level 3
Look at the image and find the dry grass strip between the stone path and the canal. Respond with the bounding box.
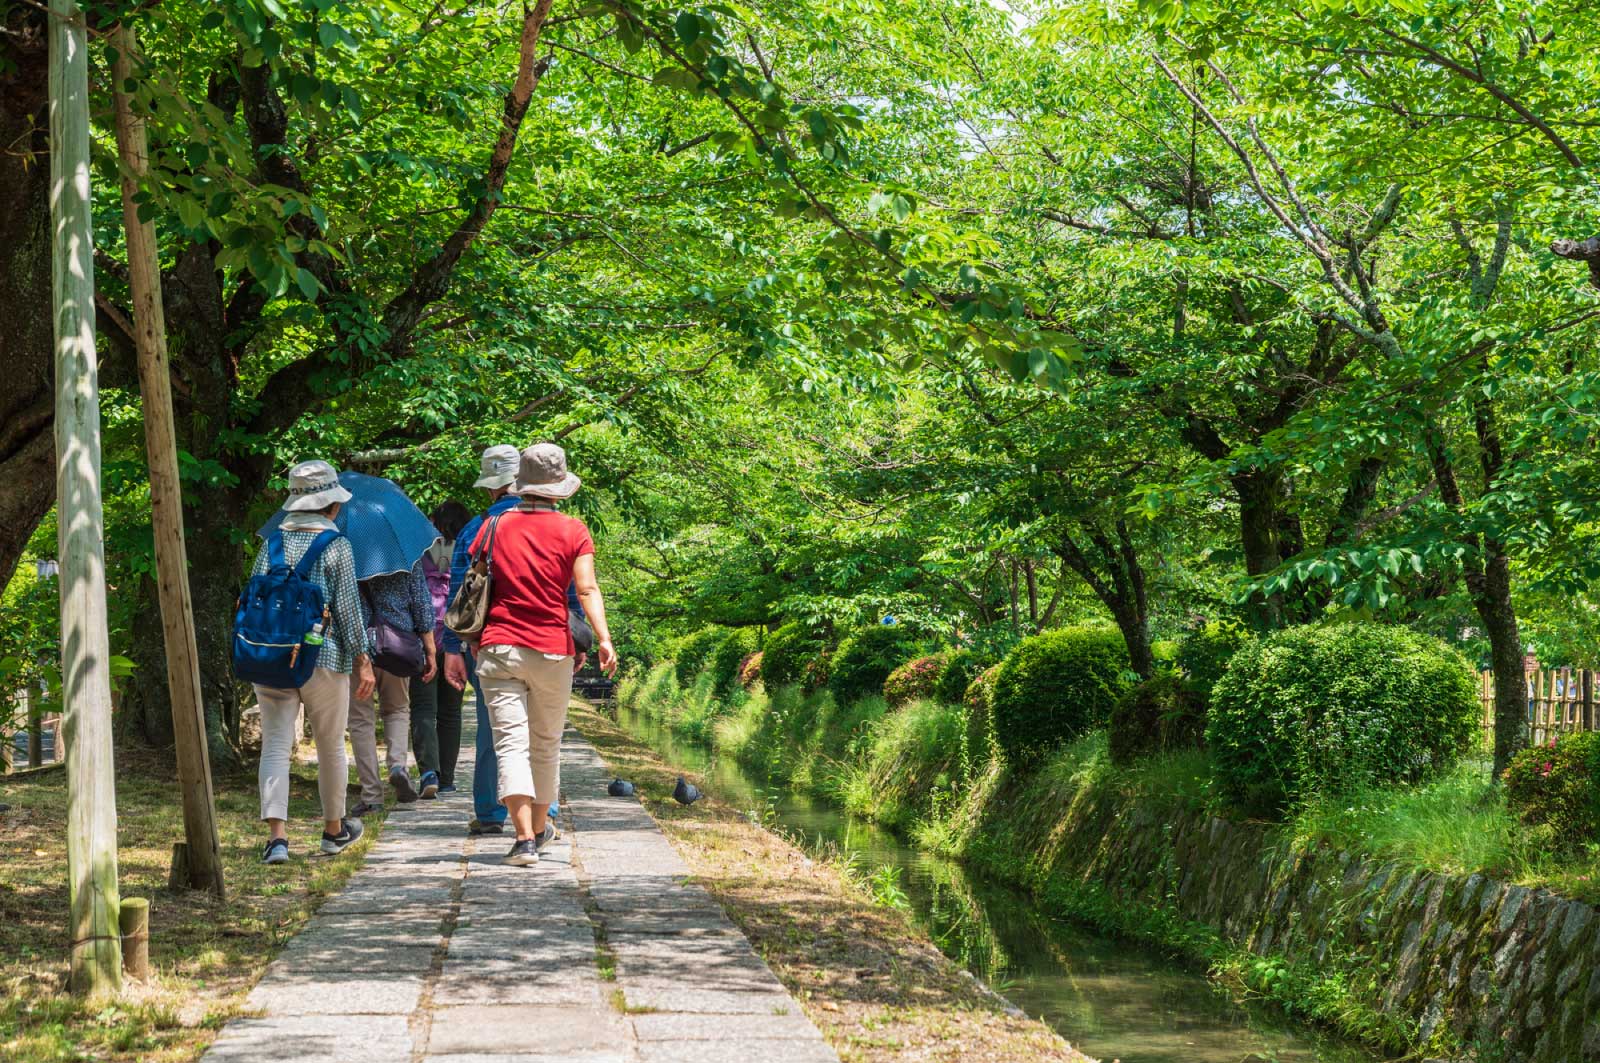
[573,703,1088,1063]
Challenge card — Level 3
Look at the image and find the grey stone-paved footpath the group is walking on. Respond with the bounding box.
[205,719,838,1063]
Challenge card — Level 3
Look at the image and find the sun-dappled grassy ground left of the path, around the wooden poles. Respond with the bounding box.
[0,751,379,1063]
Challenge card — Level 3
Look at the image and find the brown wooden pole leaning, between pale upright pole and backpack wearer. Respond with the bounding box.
[110,26,226,900]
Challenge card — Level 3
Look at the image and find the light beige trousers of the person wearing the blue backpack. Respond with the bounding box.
[256,668,350,820]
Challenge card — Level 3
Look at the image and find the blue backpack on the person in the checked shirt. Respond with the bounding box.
[234,532,339,690]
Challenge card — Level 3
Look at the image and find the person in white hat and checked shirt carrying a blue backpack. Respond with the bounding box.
[234,461,376,864]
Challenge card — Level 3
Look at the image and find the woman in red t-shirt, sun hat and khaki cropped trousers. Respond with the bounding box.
[472,443,616,866]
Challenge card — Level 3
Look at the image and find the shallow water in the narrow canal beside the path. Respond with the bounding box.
[619,709,1378,1063]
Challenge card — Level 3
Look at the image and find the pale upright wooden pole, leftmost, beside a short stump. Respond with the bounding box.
[48,0,122,996]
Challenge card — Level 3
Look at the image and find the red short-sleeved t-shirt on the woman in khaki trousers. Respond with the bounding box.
[472,509,595,655]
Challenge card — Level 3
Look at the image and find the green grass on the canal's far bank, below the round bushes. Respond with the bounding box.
[621,659,1597,1052]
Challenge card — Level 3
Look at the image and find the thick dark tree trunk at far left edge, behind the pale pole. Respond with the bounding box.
[0,5,56,588]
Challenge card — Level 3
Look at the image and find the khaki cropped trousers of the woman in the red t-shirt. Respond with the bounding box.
[478,645,573,805]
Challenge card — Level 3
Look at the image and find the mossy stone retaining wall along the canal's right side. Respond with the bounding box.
[1024,796,1600,1063]
